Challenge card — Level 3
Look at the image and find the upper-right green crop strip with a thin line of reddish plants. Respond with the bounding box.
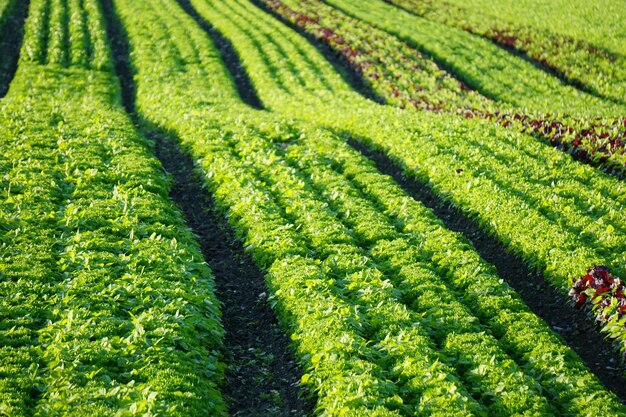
[388,0,626,104]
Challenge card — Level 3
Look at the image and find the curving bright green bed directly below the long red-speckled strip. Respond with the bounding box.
[185,0,626,358]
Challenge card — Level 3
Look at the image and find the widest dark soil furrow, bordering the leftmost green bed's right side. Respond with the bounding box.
[101,0,315,417]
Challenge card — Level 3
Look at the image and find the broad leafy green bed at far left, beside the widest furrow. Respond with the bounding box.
[0,0,224,416]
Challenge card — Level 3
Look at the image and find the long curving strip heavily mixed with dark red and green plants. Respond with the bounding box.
[263,0,626,176]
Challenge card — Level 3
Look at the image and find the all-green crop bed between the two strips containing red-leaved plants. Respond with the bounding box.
[325,0,624,117]
